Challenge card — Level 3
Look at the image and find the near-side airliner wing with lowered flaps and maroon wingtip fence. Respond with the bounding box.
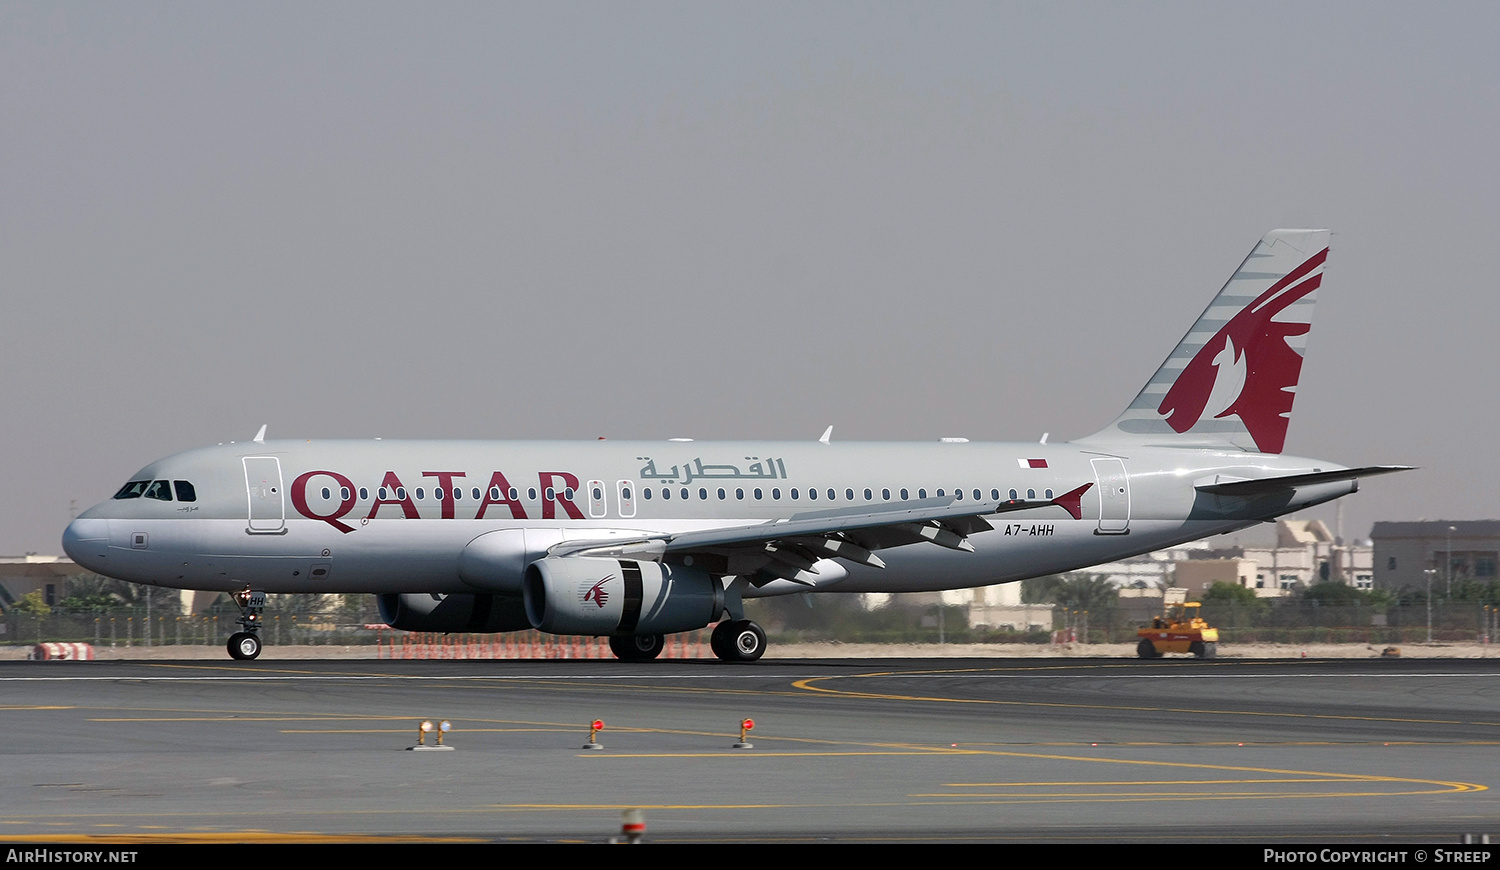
[548,483,1094,587]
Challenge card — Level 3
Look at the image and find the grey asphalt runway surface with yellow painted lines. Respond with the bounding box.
[0,659,1500,843]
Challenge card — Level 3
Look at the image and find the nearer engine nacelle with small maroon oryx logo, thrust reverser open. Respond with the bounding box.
[525,557,725,636]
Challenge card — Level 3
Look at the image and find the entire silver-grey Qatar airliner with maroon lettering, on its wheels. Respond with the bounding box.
[63,230,1404,662]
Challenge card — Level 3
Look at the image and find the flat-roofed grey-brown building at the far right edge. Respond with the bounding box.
[1370,519,1500,591]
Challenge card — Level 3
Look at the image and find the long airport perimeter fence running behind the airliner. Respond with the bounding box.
[0,600,1500,657]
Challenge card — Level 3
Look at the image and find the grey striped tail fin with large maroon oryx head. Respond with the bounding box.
[1080,230,1329,453]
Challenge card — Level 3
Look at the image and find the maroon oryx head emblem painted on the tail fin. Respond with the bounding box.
[1157,241,1328,453]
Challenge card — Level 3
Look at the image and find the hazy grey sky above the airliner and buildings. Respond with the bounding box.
[0,2,1500,554]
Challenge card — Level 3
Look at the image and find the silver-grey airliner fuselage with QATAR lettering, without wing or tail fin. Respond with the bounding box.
[65,441,1356,597]
